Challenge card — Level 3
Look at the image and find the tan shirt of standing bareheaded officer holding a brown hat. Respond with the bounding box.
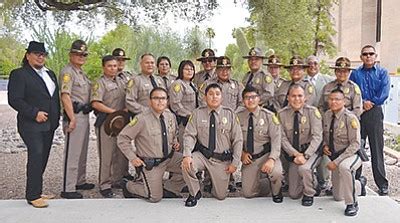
[90,75,126,110]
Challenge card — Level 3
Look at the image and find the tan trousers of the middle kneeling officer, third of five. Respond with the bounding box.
[242,153,283,198]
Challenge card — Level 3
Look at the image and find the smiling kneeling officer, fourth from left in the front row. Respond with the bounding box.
[278,84,322,206]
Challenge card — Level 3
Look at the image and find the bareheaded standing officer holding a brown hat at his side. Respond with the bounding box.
[91,55,128,198]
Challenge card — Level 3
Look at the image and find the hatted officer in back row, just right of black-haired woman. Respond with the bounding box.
[193,49,217,88]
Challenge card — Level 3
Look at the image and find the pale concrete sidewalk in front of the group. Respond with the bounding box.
[0,196,400,223]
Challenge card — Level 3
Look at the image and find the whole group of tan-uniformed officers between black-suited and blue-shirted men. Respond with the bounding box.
[12,40,376,216]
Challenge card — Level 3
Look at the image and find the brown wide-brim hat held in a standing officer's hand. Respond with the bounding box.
[104,111,129,136]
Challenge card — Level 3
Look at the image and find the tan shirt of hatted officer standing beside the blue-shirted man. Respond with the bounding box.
[318,80,363,118]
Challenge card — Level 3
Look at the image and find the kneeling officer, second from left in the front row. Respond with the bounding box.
[182,84,243,207]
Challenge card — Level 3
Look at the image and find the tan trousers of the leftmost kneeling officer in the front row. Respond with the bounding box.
[126,152,186,202]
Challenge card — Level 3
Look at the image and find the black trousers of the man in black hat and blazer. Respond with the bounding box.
[18,130,54,201]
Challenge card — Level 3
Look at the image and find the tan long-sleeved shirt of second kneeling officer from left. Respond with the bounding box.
[183,106,243,167]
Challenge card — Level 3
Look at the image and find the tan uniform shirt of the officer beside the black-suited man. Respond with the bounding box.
[59,63,91,104]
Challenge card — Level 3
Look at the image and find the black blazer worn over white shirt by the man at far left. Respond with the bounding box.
[8,64,60,131]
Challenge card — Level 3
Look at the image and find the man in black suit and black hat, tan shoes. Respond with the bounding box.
[8,41,60,208]
